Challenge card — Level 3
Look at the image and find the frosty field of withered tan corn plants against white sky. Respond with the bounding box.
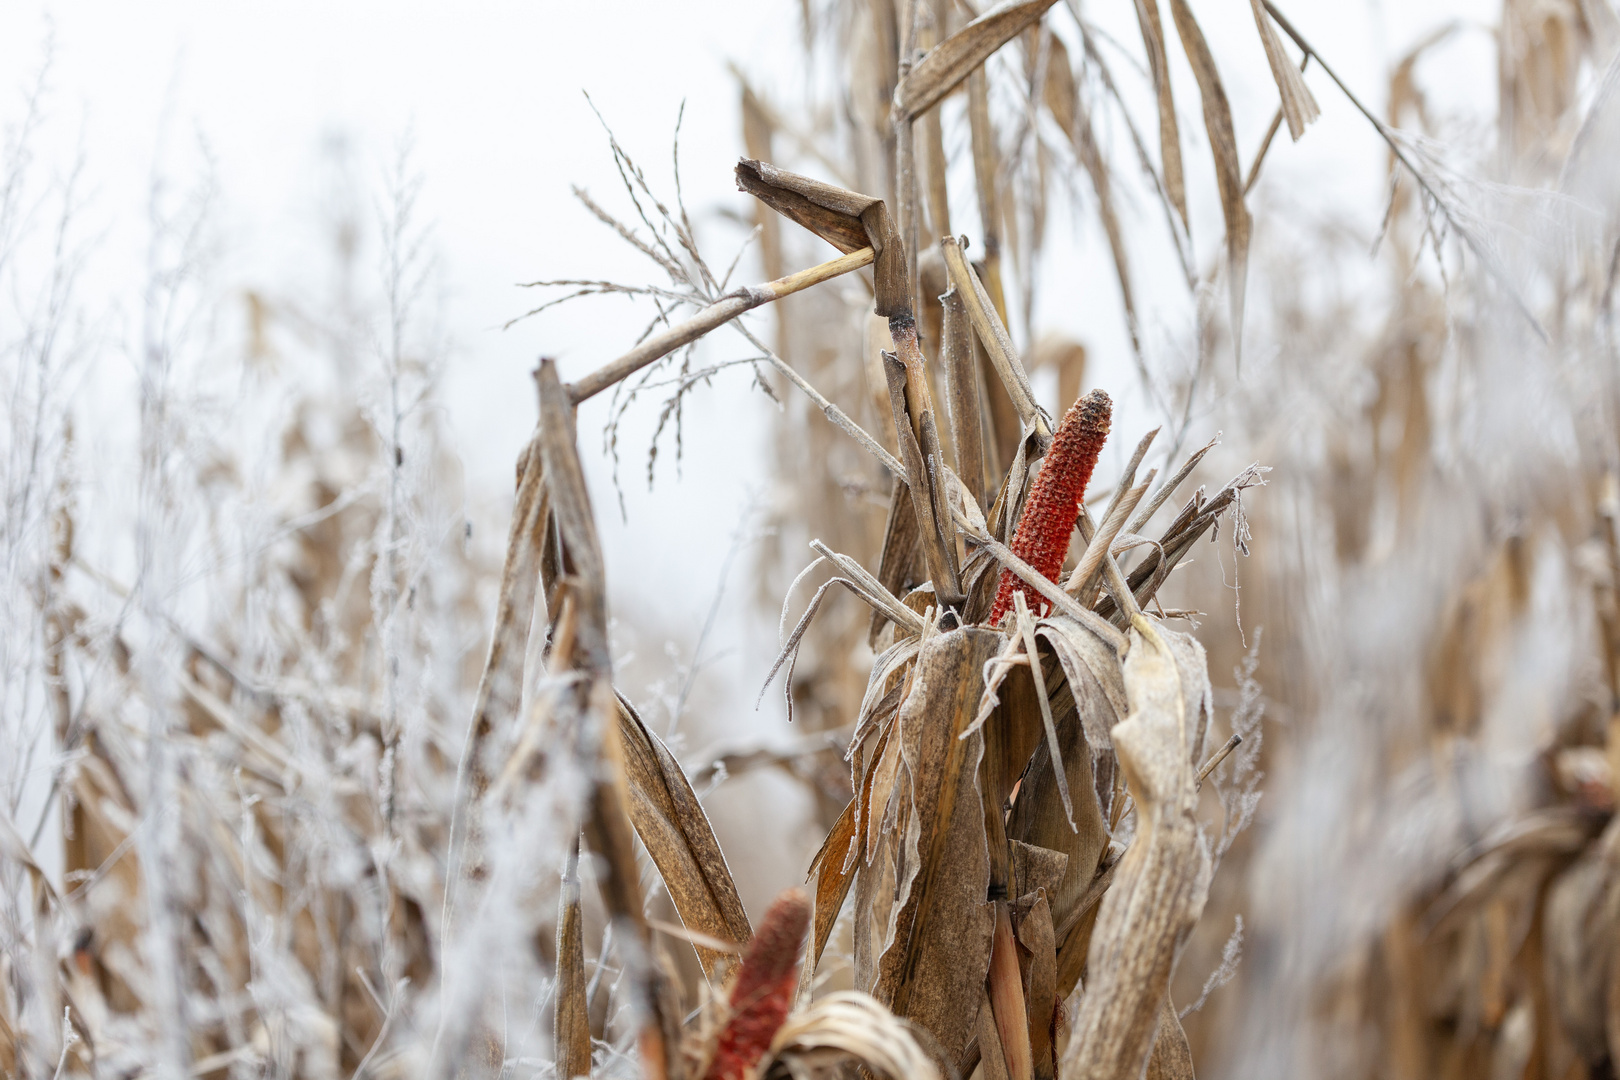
[0,0,1620,1080]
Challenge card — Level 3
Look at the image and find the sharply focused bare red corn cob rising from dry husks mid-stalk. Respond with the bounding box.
[988,390,1113,627]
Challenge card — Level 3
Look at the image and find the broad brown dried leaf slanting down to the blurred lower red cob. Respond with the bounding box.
[619,695,753,978]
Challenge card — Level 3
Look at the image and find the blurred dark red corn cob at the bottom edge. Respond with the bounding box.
[703,889,810,1080]
